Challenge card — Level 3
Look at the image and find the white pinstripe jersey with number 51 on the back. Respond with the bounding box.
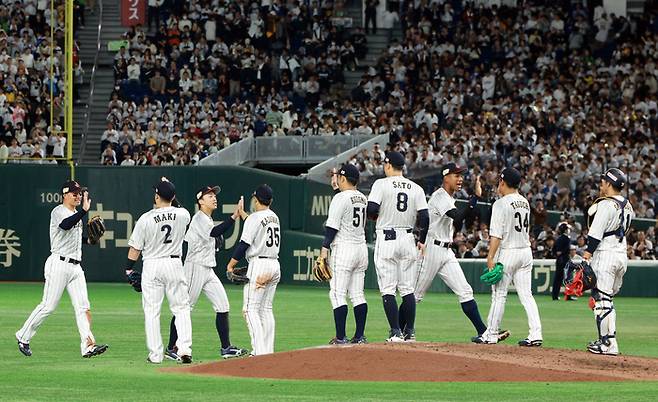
[326,190,368,244]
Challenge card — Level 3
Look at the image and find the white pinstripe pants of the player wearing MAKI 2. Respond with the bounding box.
[142,257,192,363]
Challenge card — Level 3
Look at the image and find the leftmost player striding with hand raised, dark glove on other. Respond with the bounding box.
[16,181,108,357]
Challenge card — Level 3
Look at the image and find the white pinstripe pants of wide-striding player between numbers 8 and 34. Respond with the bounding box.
[414,241,473,303]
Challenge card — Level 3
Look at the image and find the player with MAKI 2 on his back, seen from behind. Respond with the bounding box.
[126,177,192,364]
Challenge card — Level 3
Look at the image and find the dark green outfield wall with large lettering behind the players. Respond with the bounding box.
[0,165,658,296]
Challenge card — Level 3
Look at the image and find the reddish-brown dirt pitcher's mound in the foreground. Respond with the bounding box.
[170,343,658,382]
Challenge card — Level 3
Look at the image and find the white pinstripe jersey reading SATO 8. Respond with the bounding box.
[368,176,427,229]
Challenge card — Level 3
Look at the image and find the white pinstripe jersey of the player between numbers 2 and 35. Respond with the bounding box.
[185,211,217,267]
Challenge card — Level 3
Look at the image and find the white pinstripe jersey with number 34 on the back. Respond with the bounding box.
[489,193,530,248]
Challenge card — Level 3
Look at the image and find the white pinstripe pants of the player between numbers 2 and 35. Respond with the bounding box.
[183,262,229,313]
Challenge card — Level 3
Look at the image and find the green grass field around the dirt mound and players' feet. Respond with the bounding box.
[0,283,658,402]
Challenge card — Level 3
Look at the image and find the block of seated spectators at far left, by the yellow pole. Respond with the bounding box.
[0,0,77,164]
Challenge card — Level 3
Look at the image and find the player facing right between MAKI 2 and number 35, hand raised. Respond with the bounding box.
[165,186,247,361]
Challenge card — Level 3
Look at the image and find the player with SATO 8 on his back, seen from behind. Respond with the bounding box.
[367,151,429,342]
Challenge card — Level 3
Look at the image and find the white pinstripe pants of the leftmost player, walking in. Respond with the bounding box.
[16,254,96,355]
